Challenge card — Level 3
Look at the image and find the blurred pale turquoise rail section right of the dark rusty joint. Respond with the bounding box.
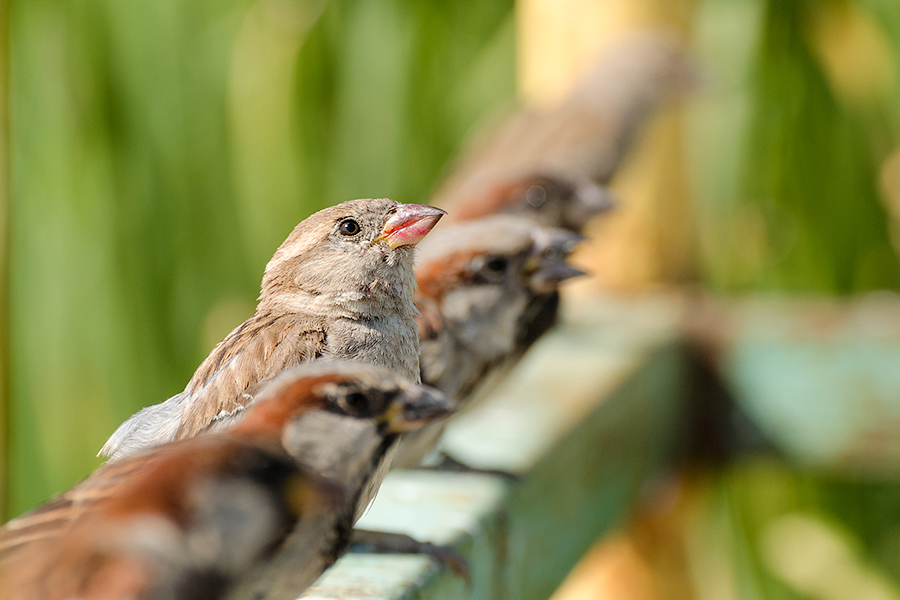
[705,297,900,475]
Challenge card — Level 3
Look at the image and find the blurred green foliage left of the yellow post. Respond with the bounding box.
[9,0,514,514]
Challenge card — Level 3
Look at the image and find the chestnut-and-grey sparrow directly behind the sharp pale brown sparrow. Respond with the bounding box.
[393,215,584,468]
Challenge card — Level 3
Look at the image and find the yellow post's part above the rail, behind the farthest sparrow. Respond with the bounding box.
[517,0,695,290]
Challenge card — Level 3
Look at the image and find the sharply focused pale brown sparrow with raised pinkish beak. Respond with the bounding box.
[100,199,446,460]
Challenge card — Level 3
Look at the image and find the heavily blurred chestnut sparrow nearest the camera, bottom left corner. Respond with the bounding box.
[0,428,343,600]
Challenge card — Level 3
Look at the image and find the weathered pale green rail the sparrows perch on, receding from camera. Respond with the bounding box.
[304,299,686,600]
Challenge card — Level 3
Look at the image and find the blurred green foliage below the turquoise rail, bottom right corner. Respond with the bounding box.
[695,458,900,600]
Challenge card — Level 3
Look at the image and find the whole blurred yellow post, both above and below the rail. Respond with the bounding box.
[517,0,696,600]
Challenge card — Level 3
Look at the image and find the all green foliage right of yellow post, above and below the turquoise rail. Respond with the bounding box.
[689,0,900,600]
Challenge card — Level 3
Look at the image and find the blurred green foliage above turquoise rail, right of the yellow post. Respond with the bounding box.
[689,0,900,294]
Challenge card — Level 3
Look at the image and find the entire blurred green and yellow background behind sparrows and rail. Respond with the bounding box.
[0,0,900,599]
